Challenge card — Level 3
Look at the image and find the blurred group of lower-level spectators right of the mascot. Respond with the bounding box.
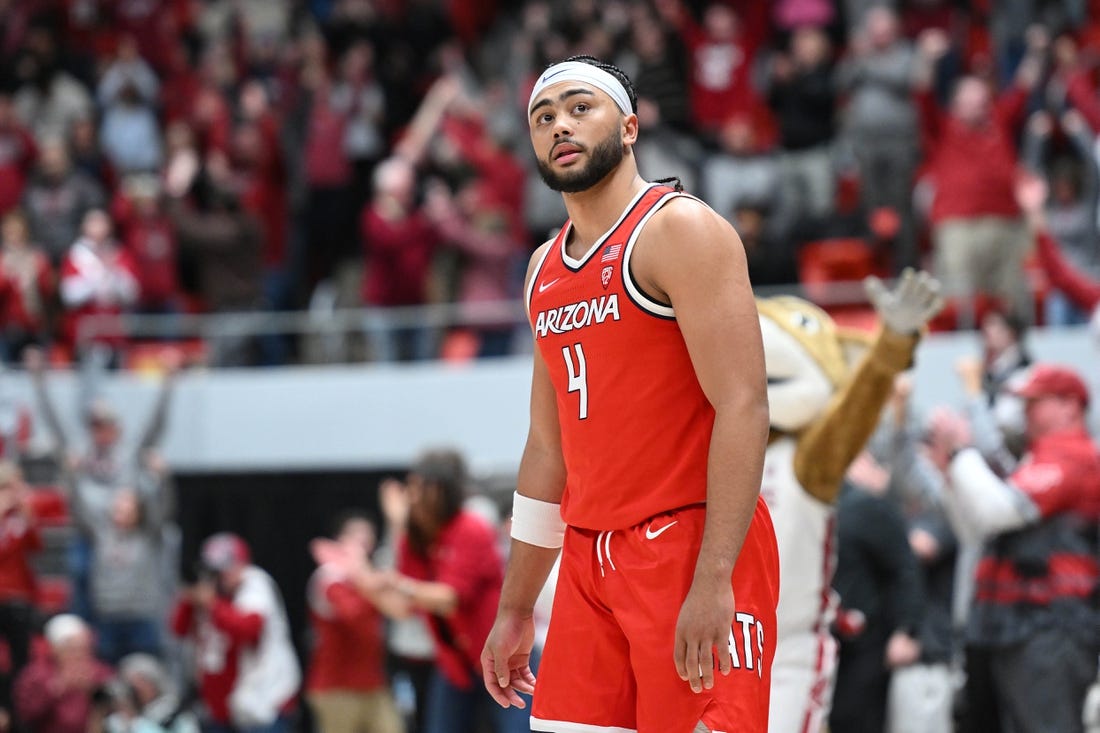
[831,319,1100,733]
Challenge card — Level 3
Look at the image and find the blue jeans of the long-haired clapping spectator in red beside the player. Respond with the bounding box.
[425,669,531,733]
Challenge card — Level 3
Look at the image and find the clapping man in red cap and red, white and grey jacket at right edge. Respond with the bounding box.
[932,363,1100,733]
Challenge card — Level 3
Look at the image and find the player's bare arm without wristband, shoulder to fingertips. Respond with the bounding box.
[633,193,768,692]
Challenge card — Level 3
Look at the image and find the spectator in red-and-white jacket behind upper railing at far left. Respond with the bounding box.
[61,209,140,358]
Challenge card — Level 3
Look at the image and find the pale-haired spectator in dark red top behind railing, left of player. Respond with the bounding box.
[360,157,440,361]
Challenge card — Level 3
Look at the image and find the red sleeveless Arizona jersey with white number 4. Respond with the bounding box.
[527,185,714,529]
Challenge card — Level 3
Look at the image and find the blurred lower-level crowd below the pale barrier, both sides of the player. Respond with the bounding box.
[0,308,1100,733]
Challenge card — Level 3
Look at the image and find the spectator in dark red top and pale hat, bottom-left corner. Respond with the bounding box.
[14,613,112,733]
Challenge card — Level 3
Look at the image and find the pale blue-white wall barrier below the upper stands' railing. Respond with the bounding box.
[0,327,1100,473]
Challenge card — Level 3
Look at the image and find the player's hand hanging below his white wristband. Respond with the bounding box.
[482,612,535,708]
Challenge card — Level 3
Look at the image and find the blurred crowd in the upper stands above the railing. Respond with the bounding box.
[0,0,1100,364]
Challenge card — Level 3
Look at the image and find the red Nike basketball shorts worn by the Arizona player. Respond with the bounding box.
[531,501,779,733]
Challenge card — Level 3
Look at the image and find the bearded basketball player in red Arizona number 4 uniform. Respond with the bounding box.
[482,56,779,733]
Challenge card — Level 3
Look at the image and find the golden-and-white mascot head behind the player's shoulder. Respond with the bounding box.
[757,296,870,433]
